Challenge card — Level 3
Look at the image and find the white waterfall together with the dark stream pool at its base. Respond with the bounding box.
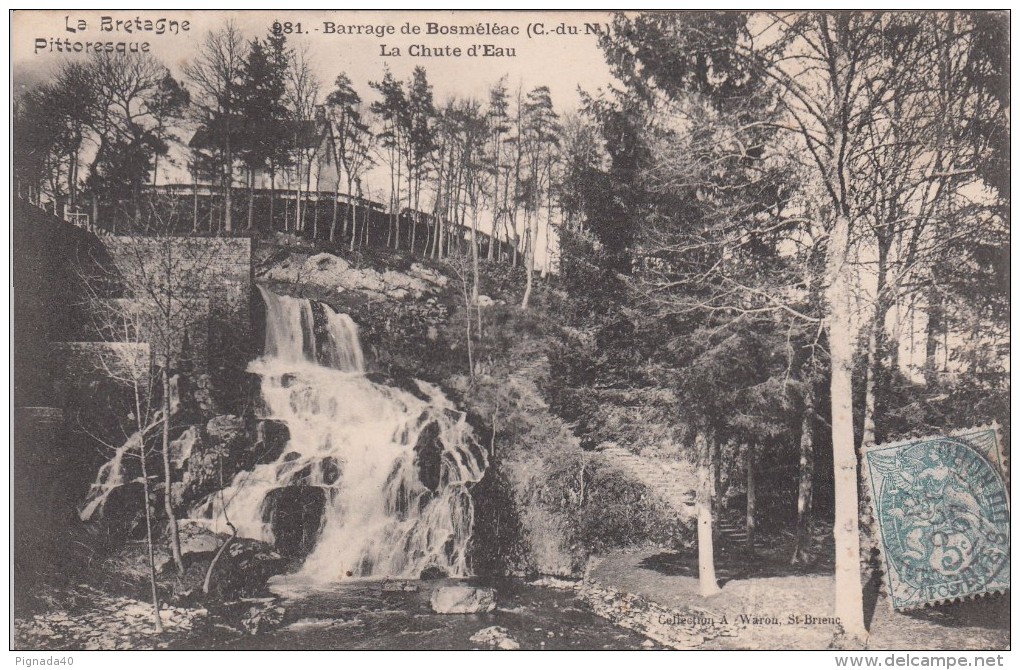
[174,287,645,650]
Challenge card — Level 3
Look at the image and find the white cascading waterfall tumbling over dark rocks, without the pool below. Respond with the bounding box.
[193,287,487,581]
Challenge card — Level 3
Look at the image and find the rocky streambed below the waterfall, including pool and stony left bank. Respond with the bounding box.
[15,578,661,651]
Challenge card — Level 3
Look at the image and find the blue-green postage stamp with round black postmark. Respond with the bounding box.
[864,424,1010,610]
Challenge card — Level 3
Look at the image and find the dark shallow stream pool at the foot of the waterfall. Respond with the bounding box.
[173,576,646,650]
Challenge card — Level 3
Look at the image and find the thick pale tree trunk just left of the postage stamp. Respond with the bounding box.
[826,213,867,640]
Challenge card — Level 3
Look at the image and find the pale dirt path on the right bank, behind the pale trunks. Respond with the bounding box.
[582,550,1010,650]
